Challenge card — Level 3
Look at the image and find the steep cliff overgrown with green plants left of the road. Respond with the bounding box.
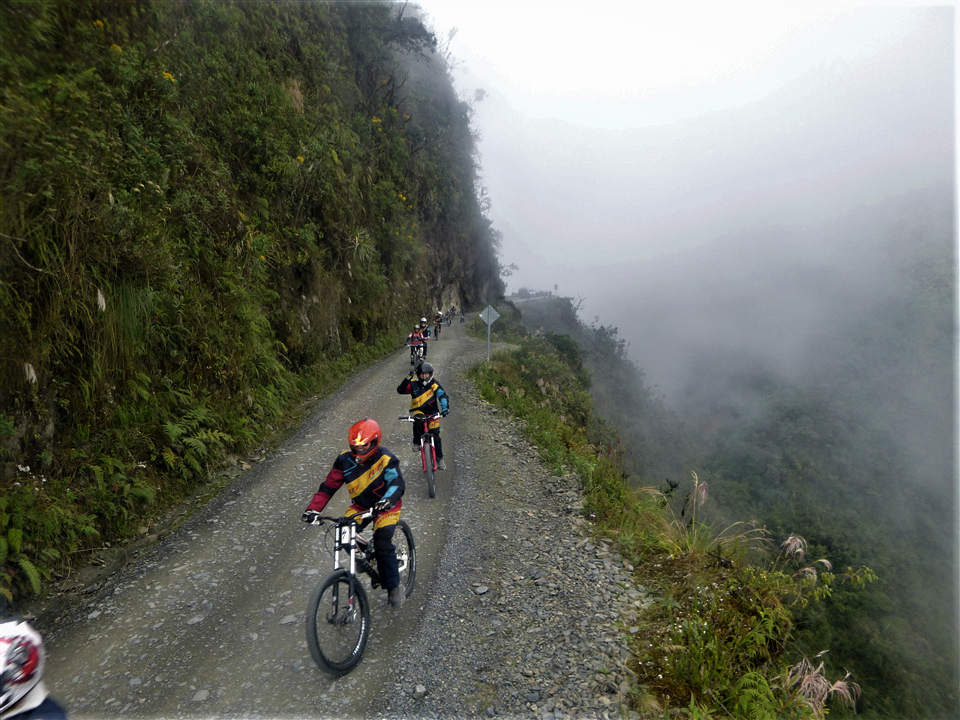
[0,0,502,592]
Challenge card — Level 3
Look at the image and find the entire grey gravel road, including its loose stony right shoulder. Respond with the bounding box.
[37,324,653,719]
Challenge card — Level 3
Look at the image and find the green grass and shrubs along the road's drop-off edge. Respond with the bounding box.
[472,332,875,718]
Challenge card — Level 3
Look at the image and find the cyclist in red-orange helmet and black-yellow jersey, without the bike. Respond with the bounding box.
[301,418,404,607]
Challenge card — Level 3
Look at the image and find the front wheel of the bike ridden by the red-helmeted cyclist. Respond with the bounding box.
[307,570,370,677]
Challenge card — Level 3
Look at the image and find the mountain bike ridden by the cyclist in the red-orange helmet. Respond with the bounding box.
[307,510,417,677]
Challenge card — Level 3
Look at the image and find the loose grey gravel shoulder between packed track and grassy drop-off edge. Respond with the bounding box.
[371,352,655,719]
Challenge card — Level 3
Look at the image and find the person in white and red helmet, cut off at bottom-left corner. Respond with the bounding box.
[0,617,67,720]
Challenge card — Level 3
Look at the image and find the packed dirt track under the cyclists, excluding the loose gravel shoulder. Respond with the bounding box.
[44,324,478,719]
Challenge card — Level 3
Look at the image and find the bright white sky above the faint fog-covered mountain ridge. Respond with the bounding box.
[423,0,908,129]
